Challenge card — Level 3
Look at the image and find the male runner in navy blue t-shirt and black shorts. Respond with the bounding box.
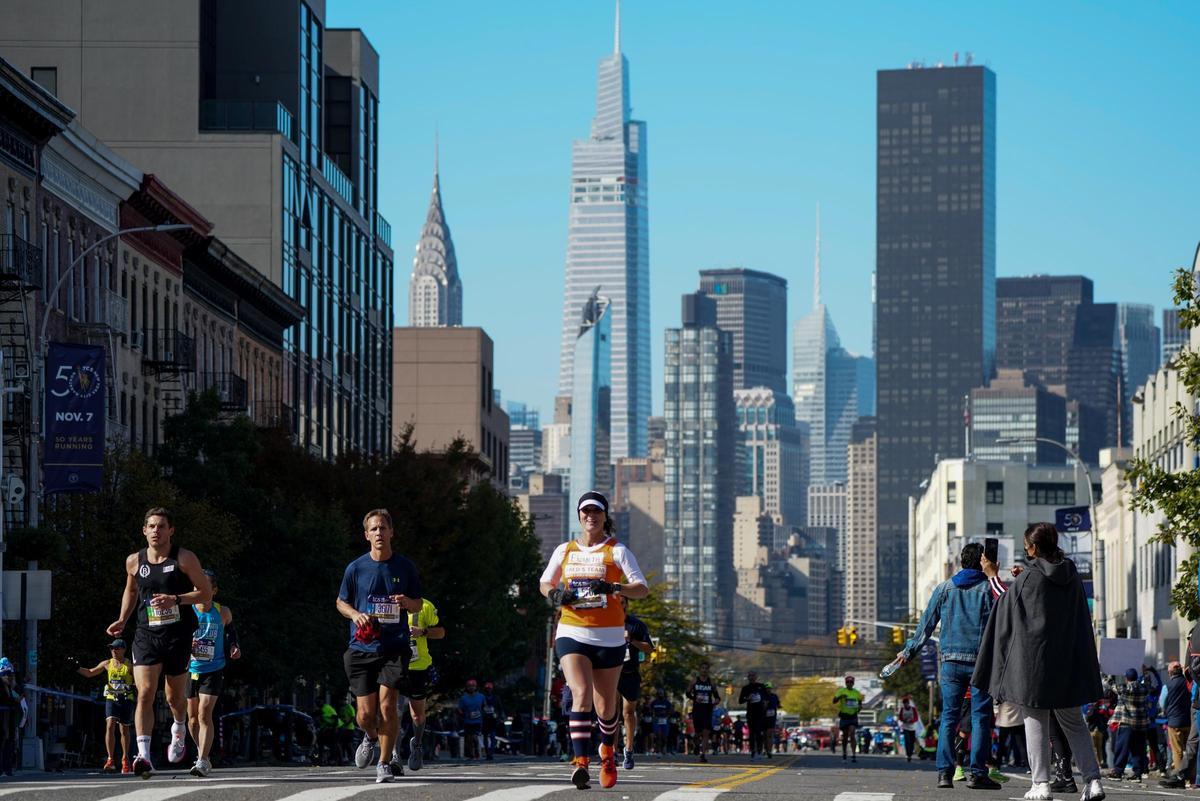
[337,508,421,783]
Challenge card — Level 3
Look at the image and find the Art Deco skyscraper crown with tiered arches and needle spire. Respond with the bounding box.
[408,153,462,327]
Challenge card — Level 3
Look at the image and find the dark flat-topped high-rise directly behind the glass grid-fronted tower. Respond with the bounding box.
[700,267,787,395]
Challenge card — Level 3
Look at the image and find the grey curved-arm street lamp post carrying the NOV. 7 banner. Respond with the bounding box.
[17,223,192,766]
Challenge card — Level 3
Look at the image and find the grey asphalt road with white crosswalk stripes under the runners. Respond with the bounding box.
[0,753,1185,801]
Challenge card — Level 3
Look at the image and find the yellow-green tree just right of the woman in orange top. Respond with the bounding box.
[629,583,708,697]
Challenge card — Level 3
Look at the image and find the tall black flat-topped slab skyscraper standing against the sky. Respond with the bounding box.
[875,66,996,620]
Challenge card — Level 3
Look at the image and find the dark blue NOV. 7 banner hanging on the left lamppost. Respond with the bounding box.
[42,342,107,493]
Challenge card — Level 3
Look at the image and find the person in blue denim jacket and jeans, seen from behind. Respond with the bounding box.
[896,542,1000,790]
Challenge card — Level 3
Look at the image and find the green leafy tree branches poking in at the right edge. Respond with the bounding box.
[1127,263,1200,620]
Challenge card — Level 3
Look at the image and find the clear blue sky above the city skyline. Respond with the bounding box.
[328,0,1200,420]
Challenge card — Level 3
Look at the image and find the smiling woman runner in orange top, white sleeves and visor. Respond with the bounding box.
[541,492,648,790]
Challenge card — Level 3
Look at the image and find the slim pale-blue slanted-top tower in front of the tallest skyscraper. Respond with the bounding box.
[570,290,612,531]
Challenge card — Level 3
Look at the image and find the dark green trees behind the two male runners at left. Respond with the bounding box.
[34,396,548,693]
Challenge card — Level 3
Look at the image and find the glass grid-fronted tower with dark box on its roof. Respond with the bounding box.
[662,293,736,638]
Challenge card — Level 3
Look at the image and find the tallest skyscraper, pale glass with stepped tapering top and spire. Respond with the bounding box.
[558,4,650,462]
